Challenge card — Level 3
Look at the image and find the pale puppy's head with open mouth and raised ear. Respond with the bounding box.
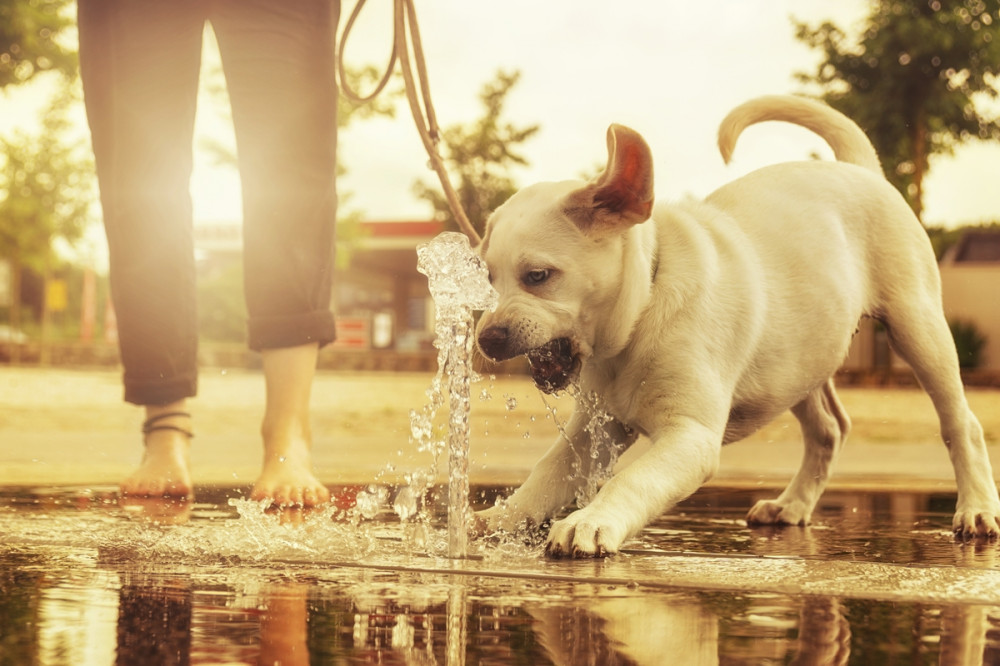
[477,125,653,392]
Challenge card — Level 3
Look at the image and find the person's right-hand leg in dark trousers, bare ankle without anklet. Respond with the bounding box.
[211,0,339,506]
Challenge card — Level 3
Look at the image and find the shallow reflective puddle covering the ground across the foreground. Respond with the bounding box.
[0,480,1000,665]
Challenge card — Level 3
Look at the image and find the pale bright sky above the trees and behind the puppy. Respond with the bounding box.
[0,0,1000,239]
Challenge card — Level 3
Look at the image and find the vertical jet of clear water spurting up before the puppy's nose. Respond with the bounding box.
[410,232,498,558]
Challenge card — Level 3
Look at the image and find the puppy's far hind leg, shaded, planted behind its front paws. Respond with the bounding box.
[747,379,851,525]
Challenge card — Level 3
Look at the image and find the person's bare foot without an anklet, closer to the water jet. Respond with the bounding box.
[250,438,330,506]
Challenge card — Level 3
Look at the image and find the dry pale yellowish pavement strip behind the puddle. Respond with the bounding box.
[0,367,1000,491]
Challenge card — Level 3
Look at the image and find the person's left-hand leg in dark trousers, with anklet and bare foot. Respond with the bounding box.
[78,0,204,496]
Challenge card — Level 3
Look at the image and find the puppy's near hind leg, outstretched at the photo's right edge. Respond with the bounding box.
[882,304,1000,538]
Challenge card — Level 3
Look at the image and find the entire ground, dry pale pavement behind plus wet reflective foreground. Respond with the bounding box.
[0,368,1000,666]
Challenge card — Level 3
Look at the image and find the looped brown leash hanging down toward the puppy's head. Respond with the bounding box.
[337,0,482,247]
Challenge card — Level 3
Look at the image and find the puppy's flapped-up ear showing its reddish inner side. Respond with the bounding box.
[565,125,653,232]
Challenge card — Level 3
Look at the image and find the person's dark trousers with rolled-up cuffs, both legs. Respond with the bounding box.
[78,0,340,405]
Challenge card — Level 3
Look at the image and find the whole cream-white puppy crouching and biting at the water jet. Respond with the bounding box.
[477,97,1000,557]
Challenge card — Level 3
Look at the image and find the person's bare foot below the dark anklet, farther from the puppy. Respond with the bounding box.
[121,430,192,497]
